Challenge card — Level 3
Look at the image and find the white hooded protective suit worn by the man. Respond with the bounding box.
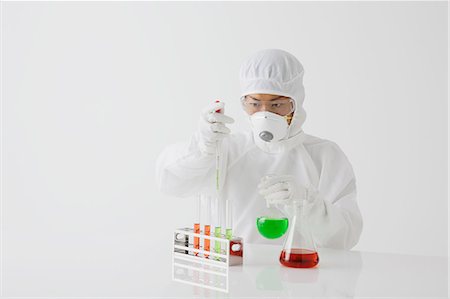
[156,49,362,249]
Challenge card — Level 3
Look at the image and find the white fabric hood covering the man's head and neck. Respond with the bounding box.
[239,49,306,153]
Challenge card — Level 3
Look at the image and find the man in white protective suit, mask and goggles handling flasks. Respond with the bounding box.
[157,49,362,249]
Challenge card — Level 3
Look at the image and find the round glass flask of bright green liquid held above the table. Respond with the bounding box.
[256,206,289,239]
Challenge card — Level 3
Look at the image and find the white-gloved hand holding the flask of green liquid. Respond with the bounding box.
[258,175,319,216]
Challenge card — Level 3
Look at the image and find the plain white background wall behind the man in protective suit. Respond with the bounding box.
[1,2,448,292]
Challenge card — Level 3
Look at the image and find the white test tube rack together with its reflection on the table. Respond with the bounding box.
[172,228,243,293]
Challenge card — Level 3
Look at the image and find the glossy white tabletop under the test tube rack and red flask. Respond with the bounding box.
[3,240,448,298]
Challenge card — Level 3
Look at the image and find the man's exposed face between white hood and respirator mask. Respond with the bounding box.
[242,93,294,124]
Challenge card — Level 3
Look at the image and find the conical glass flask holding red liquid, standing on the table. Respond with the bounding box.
[280,201,319,268]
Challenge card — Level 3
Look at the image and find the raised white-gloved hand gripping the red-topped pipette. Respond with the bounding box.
[198,102,234,155]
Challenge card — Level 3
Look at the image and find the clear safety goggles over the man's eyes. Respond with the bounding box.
[241,96,295,116]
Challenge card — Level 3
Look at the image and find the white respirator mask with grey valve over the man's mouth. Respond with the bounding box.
[250,111,289,143]
